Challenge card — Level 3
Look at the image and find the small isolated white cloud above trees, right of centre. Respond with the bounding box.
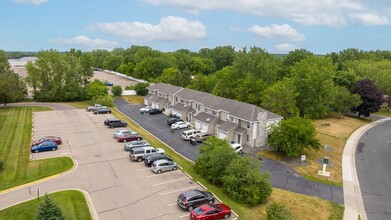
[248,24,305,41]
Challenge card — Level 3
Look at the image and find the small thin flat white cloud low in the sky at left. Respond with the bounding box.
[52,35,118,49]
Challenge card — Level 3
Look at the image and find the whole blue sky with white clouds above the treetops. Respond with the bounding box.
[0,0,391,54]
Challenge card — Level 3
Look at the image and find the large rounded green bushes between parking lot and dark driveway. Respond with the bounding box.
[194,138,272,207]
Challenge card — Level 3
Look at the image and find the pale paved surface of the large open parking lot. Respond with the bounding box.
[32,109,217,220]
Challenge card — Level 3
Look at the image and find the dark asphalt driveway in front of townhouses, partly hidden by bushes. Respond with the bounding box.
[115,99,343,204]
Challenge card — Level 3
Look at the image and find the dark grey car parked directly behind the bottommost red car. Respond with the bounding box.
[177,189,215,211]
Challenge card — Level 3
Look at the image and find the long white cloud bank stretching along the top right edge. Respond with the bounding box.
[141,0,390,27]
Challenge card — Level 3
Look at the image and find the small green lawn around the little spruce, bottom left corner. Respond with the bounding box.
[0,190,92,220]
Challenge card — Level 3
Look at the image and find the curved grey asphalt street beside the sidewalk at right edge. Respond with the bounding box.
[356,120,391,219]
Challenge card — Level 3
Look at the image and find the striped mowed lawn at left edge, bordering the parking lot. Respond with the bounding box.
[0,107,73,191]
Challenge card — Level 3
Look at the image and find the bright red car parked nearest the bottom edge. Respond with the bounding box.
[190,204,231,220]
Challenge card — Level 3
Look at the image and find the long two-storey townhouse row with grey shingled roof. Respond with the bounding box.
[144,83,282,147]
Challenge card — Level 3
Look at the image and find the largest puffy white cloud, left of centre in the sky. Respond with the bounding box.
[86,16,206,43]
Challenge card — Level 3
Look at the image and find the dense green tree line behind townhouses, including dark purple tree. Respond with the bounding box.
[91,46,391,119]
